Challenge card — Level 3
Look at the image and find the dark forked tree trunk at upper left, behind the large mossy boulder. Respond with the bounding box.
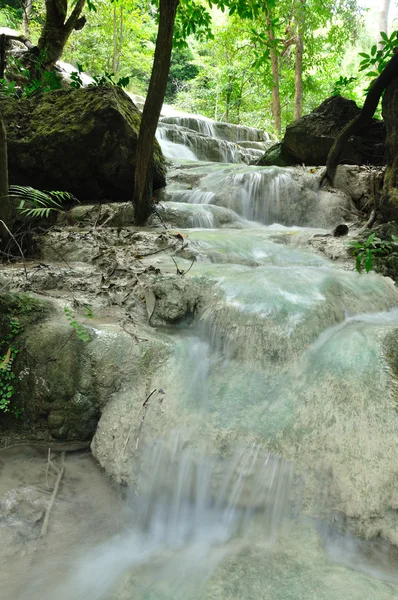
[37,0,86,71]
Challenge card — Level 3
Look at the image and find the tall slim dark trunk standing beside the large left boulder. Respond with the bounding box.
[133,0,179,225]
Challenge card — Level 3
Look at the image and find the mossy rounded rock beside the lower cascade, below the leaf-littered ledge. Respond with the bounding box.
[0,294,173,441]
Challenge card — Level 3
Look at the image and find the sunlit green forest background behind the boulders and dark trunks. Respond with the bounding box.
[0,0,398,136]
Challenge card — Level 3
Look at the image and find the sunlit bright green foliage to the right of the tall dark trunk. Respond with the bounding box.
[176,0,360,132]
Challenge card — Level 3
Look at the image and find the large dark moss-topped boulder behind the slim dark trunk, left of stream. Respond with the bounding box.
[0,86,166,202]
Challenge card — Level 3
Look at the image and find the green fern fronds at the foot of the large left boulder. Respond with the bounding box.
[9,185,78,219]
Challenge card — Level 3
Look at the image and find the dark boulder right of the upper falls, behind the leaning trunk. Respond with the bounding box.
[257,96,386,166]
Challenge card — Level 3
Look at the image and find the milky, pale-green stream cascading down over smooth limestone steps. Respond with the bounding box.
[4,117,398,600]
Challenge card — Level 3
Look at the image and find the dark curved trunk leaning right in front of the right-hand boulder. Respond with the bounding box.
[322,53,398,185]
